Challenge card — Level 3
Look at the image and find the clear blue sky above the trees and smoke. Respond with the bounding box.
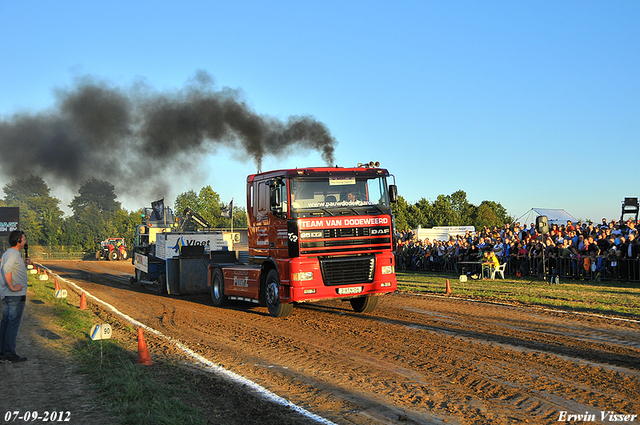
[0,0,640,221]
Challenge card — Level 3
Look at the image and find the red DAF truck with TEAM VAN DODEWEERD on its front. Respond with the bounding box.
[207,163,397,317]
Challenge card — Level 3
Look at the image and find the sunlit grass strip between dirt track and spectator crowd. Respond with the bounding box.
[397,272,640,319]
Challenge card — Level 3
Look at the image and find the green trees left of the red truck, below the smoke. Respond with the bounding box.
[0,175,247,252]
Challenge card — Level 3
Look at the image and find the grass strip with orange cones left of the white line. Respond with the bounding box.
[29,275,208,425]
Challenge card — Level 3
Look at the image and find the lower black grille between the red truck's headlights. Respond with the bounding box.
[320,256,376,286]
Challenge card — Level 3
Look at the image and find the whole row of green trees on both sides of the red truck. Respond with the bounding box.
[0,175,513,252]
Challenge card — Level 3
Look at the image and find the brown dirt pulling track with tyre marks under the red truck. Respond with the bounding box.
[38,261,640,424]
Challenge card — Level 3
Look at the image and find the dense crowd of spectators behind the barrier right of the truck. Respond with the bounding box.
[395,218,640,281]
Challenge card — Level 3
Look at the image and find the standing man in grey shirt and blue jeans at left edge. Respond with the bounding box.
[0,230,28,363]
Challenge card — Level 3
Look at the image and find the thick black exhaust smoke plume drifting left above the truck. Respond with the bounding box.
[0,71,336,200]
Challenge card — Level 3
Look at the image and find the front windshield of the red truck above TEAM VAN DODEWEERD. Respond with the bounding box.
[289,177,390,211]
